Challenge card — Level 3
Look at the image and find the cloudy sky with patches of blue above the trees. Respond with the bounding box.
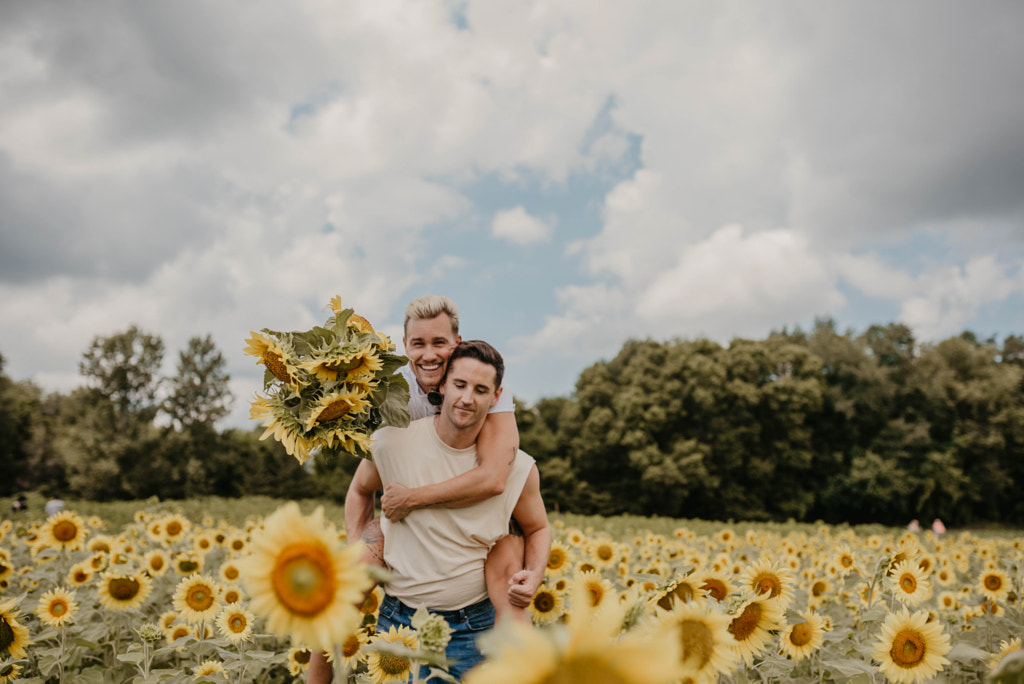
[0,0,1024,427]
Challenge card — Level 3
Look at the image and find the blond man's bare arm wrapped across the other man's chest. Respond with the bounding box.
[381,411,519,522]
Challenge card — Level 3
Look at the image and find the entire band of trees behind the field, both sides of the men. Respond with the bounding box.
[0,319,1024,525]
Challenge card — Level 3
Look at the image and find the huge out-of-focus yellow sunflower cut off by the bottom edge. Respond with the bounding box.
[463,578,681,684]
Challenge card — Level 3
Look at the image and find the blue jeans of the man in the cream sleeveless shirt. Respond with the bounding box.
[377,594,495,681]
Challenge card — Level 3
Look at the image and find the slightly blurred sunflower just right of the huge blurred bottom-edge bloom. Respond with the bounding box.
[657,601,739,682]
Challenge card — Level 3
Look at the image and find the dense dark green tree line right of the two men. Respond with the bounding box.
[518,319,1024,524]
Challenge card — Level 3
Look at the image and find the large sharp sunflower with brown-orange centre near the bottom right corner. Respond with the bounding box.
[871,607,949,684]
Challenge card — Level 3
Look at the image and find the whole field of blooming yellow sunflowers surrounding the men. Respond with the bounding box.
[0,503,1024,684]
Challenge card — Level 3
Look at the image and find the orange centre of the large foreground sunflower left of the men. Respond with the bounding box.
[271,543,335,615]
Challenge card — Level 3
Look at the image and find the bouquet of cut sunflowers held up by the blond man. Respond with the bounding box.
[245,296,409,463]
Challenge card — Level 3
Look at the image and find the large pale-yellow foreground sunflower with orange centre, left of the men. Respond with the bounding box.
[240,502,373,650]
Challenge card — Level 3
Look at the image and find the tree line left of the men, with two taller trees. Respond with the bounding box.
[0,326,356,501]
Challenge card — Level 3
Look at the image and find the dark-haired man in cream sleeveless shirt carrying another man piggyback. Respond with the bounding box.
[345,341,551,677]
